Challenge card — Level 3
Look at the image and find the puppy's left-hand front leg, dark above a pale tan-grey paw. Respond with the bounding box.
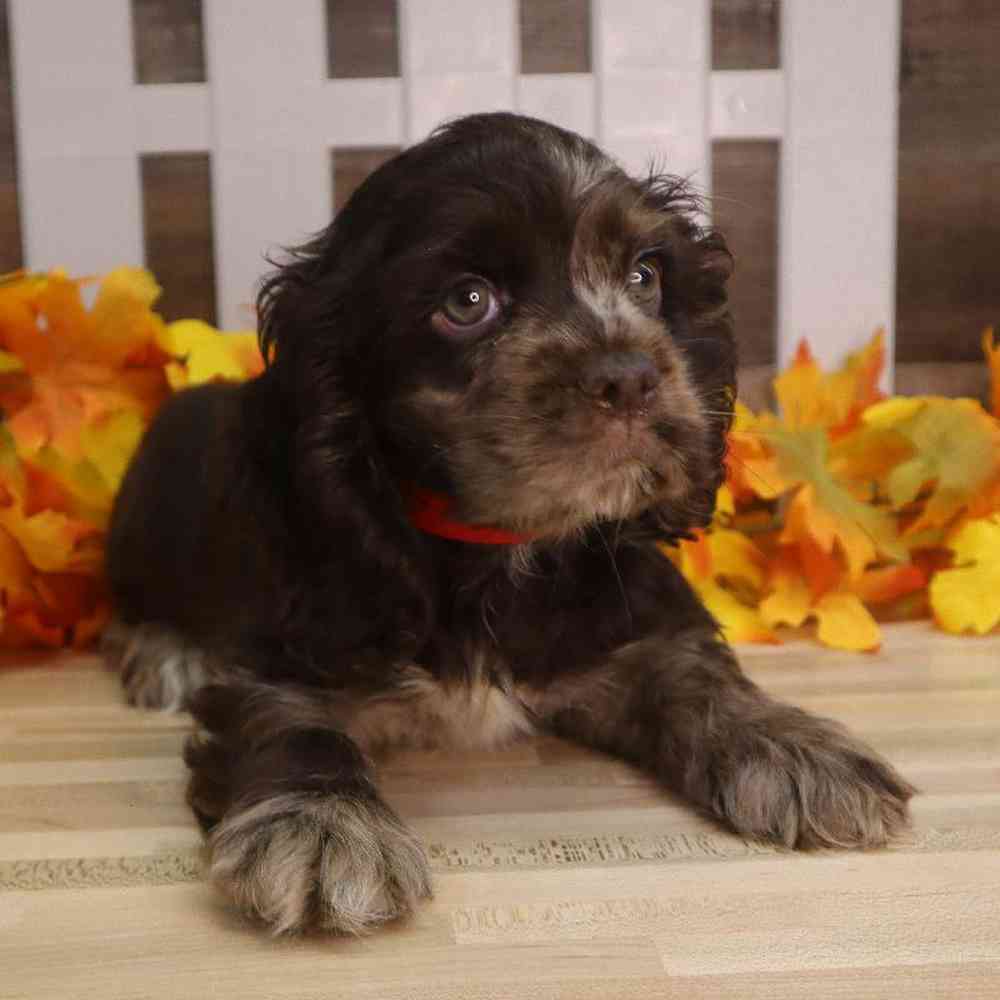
[185,682,431,934]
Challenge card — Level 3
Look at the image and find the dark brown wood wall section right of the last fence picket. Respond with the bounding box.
[896,0,1000,362]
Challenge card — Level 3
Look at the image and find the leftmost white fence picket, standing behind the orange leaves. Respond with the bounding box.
[10,0,143,274]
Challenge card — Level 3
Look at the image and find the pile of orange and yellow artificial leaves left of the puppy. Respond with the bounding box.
[0,268,263,646]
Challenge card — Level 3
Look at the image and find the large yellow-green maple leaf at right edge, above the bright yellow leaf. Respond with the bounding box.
[863,396,1000,534]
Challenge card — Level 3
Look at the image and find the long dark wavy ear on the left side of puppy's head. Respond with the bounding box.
[258,204,432,655]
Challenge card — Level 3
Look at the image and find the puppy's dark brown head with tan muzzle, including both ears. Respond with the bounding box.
[260,114,735,548]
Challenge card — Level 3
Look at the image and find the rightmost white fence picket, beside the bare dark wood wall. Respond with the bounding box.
[778,0,900,382]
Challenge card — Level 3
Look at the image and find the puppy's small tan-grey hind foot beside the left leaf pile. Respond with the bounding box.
[101,621,208,712]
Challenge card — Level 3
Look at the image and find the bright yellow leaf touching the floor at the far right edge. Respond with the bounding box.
[930,515,1000,635]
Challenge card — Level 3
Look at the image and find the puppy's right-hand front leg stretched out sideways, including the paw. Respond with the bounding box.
[540,631,914,848]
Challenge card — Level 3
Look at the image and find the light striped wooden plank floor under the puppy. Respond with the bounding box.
[0,625,1000,1000]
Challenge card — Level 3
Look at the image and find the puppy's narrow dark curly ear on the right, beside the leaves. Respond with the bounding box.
[645,175,737,536]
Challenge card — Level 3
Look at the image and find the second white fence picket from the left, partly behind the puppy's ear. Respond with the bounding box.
[204,0,333,327]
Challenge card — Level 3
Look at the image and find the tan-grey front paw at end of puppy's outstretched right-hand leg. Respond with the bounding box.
[708,708,915,849]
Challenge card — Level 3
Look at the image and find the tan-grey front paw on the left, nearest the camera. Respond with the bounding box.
[209,793,431,934]
